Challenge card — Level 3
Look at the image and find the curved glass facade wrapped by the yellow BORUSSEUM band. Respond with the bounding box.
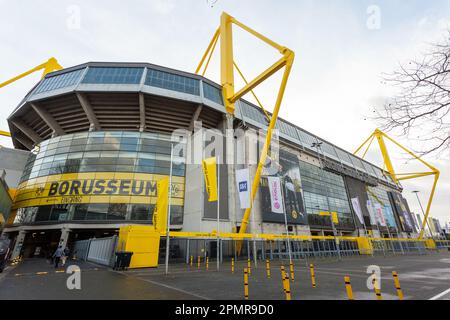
[15,131,185,224]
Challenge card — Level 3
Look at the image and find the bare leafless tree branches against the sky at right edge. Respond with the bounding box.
[375,30,450,156]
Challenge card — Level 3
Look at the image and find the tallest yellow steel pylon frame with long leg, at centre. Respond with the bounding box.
[196,12,295,252]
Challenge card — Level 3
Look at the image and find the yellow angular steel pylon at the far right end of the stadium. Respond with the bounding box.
[354,129,440,239]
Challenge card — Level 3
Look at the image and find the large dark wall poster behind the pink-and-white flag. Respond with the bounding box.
[260,150,308,224]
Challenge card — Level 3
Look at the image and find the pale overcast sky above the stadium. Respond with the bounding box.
[0,0,450,222]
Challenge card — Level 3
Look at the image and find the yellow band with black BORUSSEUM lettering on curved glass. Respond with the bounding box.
[13,172,184,209]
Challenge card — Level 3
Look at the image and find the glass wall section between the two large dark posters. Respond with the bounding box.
[300,161,354,229]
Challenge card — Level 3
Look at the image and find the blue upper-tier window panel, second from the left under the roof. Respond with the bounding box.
[82,67,144,84]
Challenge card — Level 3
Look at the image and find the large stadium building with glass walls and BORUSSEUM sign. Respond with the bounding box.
[0,62,417,256]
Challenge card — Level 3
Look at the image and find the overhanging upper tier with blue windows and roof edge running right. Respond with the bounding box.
[8,62,398,189]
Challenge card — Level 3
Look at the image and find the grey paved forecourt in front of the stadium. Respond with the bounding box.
[0,251,450,300]
